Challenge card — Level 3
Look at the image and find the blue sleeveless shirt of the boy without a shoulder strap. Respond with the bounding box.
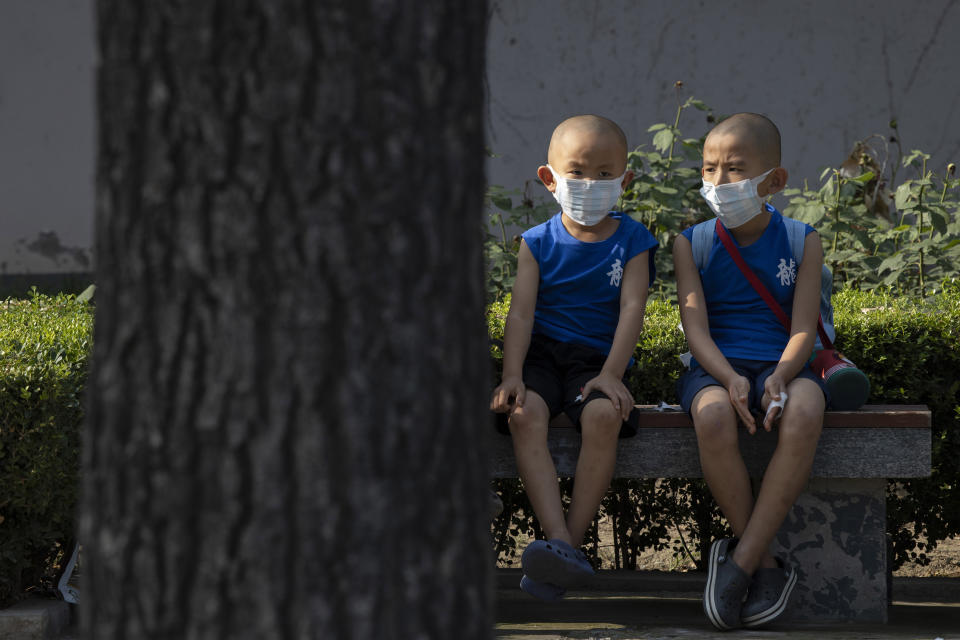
[523,213,658,354]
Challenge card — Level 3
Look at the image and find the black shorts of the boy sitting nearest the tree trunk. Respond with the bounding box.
[498,333,636,438]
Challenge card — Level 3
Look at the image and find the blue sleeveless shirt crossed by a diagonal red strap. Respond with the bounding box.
[683,207,814,362]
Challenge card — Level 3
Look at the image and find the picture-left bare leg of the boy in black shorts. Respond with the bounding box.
[510,396,572,544]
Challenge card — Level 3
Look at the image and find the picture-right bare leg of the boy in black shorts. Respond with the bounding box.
[567,398,623,547]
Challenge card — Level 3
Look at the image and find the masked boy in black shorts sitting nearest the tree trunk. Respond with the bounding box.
[490,115,657,600]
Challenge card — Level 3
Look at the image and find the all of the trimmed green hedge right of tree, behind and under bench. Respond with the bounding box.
[488,284,960,569]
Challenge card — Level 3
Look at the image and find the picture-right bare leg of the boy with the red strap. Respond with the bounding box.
[733,378,824,573]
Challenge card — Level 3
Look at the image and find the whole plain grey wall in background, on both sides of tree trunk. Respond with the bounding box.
[0,0,960,274]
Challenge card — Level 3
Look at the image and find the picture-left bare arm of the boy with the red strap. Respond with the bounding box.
[673,235,756,433]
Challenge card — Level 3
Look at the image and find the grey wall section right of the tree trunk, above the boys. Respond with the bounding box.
[487,0,960,208]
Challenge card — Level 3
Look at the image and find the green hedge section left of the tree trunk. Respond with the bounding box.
[0,293,93,605]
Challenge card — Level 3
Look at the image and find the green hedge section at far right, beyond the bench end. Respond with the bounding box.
[834,281,960,569]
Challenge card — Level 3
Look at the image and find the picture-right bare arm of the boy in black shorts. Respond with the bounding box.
[583,251,650,420]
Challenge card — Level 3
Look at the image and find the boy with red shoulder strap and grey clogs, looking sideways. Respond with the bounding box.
[673,113,828,629]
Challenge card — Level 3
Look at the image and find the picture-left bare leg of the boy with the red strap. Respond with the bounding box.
[690,386,776,574]
